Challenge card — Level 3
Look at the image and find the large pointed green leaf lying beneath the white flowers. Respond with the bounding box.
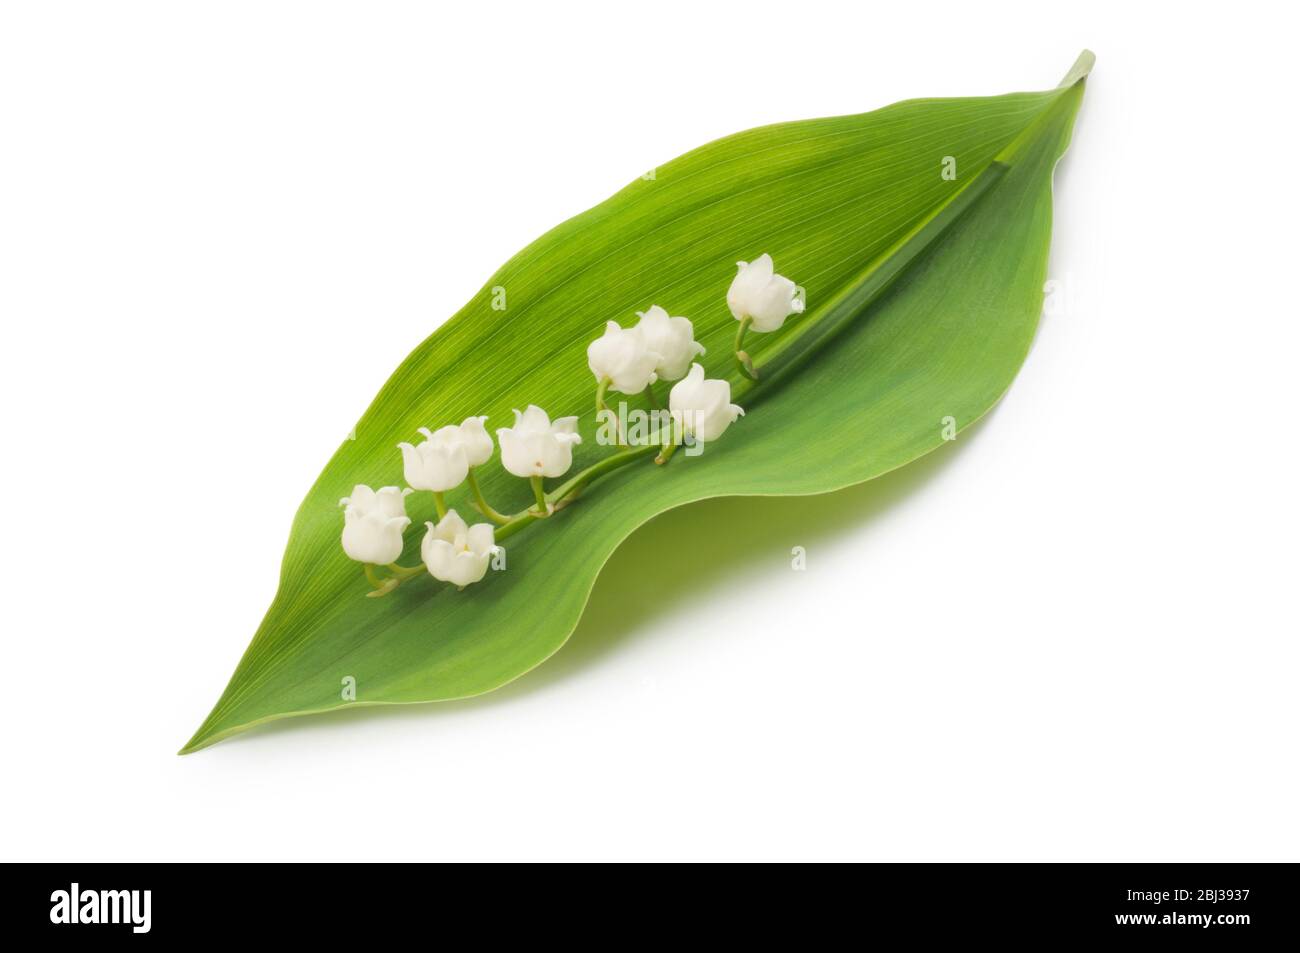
[182,52,1092,751]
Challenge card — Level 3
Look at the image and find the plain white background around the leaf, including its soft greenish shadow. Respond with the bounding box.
[0,0,1300,861]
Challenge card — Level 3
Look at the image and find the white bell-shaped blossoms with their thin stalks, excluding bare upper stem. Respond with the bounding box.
[339,255,780,597]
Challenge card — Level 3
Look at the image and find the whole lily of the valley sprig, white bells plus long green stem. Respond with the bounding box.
[341,189,1008,597]
